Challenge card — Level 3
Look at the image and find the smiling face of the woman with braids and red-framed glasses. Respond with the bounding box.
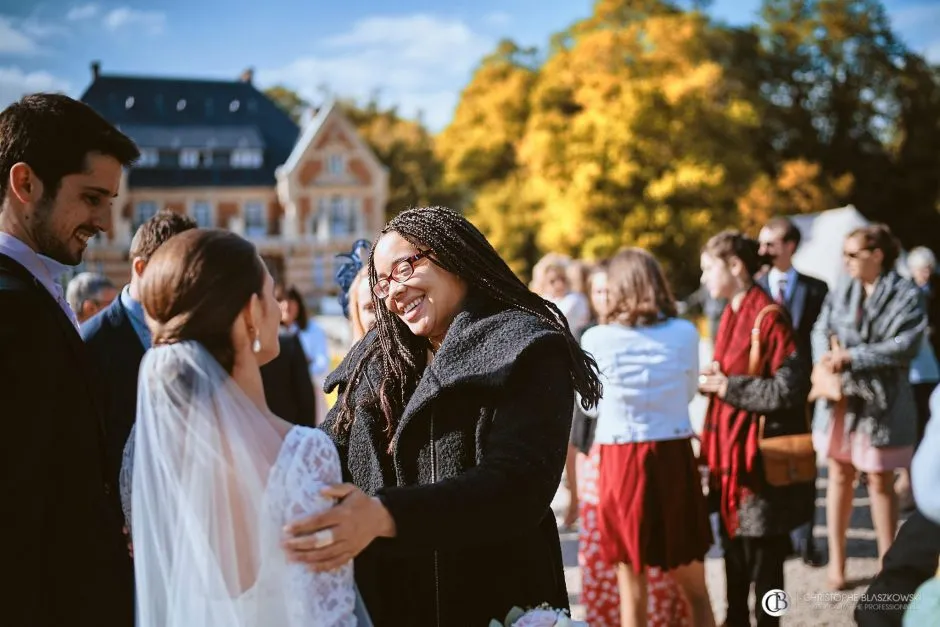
[373,231,467,342]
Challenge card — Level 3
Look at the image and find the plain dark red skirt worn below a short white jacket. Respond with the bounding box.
[598,439,712,573]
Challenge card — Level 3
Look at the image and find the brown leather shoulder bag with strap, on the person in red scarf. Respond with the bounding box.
[748,305,816,487]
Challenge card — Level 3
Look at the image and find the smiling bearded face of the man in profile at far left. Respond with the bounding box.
[11,153,121,266]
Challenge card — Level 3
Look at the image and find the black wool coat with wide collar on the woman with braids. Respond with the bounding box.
[323,300,574,627]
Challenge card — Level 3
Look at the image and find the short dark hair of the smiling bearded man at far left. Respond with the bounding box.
[0,94,140,202]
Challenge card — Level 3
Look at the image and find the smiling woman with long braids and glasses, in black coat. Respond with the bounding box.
[286,207,601,627]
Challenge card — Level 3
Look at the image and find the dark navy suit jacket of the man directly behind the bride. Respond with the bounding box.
[82,297,144,498]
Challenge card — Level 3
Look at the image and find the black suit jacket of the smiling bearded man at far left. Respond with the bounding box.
[0,254,134,627]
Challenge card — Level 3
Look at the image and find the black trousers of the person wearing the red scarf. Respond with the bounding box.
[720,524,792,627]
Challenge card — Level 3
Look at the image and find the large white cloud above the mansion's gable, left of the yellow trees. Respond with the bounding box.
[257,14,495,130]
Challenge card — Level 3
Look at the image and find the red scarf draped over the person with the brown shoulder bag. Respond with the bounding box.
[702,286,795,538]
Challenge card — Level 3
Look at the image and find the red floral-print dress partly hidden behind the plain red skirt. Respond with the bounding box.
[577,446,692,627]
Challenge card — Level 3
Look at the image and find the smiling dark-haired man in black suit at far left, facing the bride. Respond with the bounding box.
[0,94,140,627]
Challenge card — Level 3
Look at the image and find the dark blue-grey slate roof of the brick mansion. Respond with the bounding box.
[81,74,300,187]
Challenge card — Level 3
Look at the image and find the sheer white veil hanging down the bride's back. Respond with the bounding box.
[131,342,289,627]
